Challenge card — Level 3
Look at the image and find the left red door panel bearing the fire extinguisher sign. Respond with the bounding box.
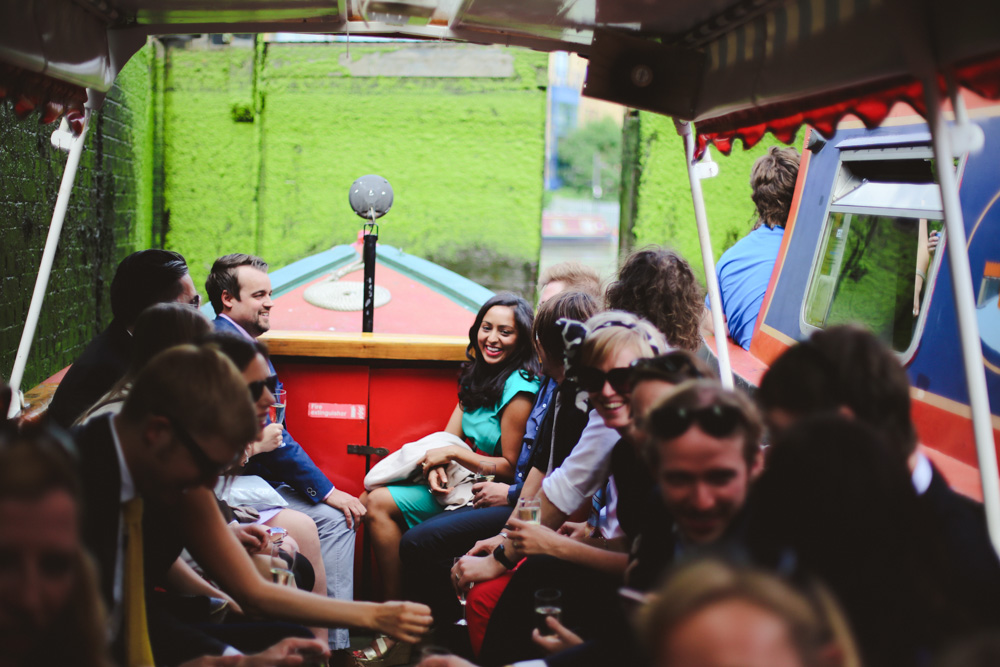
[275,359,369,495]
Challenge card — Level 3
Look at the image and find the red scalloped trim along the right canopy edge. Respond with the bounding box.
[695,56,1000,157]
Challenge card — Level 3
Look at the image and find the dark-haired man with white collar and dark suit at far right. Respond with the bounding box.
[757,326,1000,623]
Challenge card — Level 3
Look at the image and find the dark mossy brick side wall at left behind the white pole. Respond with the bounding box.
[0,47,153,388]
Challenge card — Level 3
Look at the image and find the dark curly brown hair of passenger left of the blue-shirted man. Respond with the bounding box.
[604,246,704,351]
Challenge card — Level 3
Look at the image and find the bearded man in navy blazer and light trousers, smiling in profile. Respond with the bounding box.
[205,254,366,650]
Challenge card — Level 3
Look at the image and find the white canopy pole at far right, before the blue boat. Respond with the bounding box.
[924,76,1000,554]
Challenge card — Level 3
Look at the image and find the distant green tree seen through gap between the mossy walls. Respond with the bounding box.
[556,118,622,194]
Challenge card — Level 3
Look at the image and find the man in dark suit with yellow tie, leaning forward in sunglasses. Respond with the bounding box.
[74,346,326,665]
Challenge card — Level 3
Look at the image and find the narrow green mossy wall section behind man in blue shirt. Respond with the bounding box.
[622,112,801,284]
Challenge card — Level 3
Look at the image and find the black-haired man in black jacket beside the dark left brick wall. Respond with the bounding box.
[48,248,201,427]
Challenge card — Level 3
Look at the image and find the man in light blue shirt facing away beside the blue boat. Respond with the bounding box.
[704,146,799,350]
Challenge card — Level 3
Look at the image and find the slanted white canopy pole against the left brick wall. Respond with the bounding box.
[7,109,91,418]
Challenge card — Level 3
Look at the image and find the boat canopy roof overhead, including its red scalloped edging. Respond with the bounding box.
[0,0,1000,152]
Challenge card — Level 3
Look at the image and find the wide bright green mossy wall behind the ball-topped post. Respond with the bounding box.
[164,43,547,294]
